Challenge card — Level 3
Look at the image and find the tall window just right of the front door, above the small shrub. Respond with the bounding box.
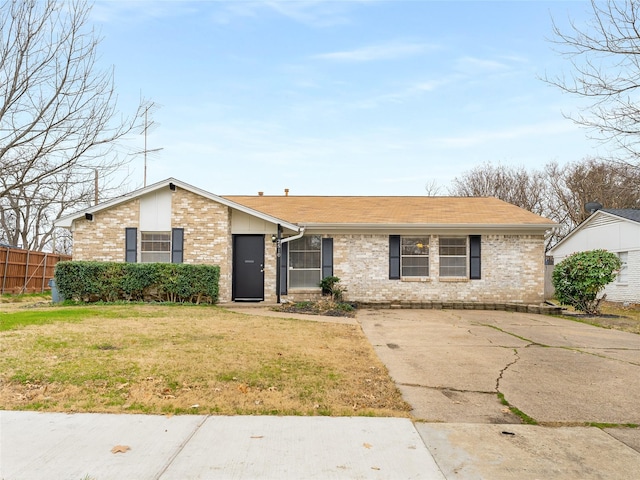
[289,235,322,288]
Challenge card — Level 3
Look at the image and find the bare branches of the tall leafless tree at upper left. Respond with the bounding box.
[0,0,138,199]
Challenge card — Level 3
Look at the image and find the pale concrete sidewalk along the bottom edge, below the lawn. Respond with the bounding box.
[0,411,445,480]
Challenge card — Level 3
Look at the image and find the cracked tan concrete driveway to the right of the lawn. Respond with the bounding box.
[358,310,640,479]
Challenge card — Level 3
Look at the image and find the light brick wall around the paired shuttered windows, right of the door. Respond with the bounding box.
[287,234,544,304]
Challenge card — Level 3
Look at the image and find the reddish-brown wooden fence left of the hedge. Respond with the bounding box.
[0,247,71,293]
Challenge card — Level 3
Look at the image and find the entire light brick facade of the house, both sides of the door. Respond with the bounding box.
[73,188,548,304]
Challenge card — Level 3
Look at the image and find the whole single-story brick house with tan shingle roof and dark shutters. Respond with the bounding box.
[56,178,555,304]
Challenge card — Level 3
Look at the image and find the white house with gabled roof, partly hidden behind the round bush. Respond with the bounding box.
[548,208,640,303]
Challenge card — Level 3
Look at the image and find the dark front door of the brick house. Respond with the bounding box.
[233,235,264,302]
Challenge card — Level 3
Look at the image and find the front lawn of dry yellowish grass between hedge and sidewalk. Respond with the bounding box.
[0,305,409,416]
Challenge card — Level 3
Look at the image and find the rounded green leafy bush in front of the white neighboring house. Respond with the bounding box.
[553,250,620,315]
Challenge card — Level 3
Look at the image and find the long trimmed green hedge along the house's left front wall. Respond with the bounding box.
[55,261,220,303]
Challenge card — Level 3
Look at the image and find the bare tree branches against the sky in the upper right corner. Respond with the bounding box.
[545,0,640,169]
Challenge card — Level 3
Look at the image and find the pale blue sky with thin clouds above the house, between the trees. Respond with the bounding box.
[91,0,604,195]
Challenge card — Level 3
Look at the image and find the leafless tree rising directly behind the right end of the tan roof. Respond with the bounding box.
[449,163,547,215]
